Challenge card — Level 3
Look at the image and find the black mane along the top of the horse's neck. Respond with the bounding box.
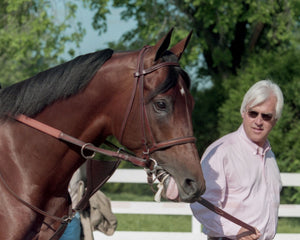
[0,49,113,118]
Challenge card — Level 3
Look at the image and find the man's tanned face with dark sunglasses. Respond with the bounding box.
[242,96,277,147]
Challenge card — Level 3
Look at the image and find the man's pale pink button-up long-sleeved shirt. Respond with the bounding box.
[191,125,282,240]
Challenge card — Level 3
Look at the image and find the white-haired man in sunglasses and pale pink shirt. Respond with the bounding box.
[191,80,283,240]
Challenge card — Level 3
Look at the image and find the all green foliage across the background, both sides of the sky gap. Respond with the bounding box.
[0,0,300,207]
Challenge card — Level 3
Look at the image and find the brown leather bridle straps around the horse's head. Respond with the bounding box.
[119,46,196,159]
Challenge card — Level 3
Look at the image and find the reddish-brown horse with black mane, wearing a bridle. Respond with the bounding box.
[0,29,205,240]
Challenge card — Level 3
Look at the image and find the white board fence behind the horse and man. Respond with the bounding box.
[94,169,300,240]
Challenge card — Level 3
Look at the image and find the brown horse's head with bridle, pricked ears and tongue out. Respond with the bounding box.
[112,30,205,202]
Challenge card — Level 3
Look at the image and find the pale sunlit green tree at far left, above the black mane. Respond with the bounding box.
[0,0,84,86]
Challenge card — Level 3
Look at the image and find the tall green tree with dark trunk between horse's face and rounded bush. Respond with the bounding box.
[83,0,300,152]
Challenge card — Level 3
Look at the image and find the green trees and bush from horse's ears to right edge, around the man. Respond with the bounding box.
[84,0,300,200]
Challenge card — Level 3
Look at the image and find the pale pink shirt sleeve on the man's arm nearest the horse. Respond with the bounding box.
[190,145,241,238]
